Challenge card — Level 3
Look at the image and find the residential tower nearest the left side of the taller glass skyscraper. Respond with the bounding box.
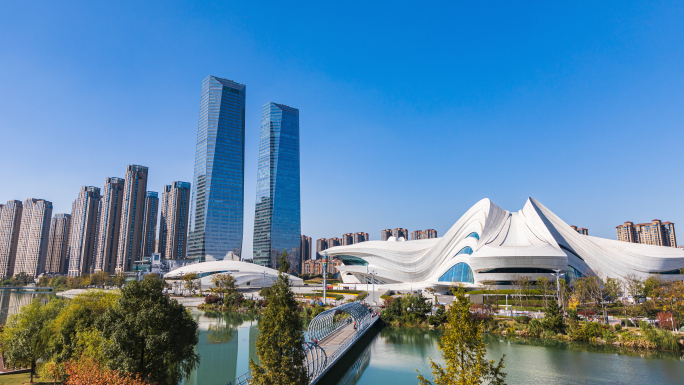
[159,182,190,259]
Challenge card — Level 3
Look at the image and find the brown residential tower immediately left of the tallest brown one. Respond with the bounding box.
[95,177,125,274]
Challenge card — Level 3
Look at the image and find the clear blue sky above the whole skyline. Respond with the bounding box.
[0,1,684,256]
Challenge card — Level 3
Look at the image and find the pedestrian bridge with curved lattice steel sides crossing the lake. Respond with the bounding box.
[226,302,378,385]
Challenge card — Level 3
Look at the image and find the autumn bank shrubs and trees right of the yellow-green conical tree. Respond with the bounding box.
[471,276,684,352]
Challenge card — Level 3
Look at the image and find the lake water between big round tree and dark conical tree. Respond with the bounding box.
[184,311,258,385]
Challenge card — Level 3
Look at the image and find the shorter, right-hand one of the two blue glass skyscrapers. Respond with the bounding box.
[254,103,301,272]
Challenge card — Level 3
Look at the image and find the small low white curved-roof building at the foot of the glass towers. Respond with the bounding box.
[164,260,304,288]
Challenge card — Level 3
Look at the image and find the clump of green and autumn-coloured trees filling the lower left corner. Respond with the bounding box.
[0,276,199,385]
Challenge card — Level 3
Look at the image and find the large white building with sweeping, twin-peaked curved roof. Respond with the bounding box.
[326,198,684,289]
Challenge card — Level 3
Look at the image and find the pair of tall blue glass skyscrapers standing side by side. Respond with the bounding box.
[188,76,301,271]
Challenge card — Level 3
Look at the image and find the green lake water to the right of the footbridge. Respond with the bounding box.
[337,328,684,385]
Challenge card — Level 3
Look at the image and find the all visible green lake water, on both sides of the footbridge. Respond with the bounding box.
[0,290,684,385]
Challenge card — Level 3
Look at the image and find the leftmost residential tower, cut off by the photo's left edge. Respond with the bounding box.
[0,200,23,278]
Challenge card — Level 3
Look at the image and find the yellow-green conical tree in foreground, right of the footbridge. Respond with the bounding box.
[418,290,506,385]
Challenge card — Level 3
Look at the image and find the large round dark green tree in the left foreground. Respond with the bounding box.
[97,279,199,384]
